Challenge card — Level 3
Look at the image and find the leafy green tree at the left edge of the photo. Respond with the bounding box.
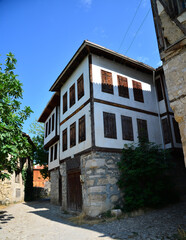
[0,53,33,180]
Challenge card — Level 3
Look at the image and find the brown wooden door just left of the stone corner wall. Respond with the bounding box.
[67,171,82,211]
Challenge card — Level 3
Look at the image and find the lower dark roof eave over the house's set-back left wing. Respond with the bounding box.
[38,92,60,123]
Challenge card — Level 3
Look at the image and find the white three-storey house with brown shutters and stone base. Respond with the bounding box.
[38,41,181,216]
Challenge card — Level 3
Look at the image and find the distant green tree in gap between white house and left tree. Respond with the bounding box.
[29,120,48,178]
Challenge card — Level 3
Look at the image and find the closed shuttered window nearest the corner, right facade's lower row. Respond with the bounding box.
[103,112,117,139]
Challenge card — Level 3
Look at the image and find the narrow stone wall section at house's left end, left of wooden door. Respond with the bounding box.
[50,169,59,205]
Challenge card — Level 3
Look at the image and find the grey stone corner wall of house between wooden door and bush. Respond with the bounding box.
[81,152,121,217]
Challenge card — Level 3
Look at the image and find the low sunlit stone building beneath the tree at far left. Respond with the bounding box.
[0,157,33,205]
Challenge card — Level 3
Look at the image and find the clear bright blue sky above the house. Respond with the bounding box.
[0,0,160,135]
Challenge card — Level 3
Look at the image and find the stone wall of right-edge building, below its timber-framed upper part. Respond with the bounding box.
[163,48,186,165]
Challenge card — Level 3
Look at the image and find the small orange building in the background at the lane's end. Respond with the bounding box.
[33,165,49,188]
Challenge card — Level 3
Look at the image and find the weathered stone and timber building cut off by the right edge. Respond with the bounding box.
[151,0,186,165]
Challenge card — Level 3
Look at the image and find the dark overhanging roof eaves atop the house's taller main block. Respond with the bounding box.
[50,40,155,91]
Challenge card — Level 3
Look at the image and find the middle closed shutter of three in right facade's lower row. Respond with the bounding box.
[121,116,134,141]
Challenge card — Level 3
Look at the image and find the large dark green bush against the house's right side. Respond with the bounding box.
[118,141,177,211]
